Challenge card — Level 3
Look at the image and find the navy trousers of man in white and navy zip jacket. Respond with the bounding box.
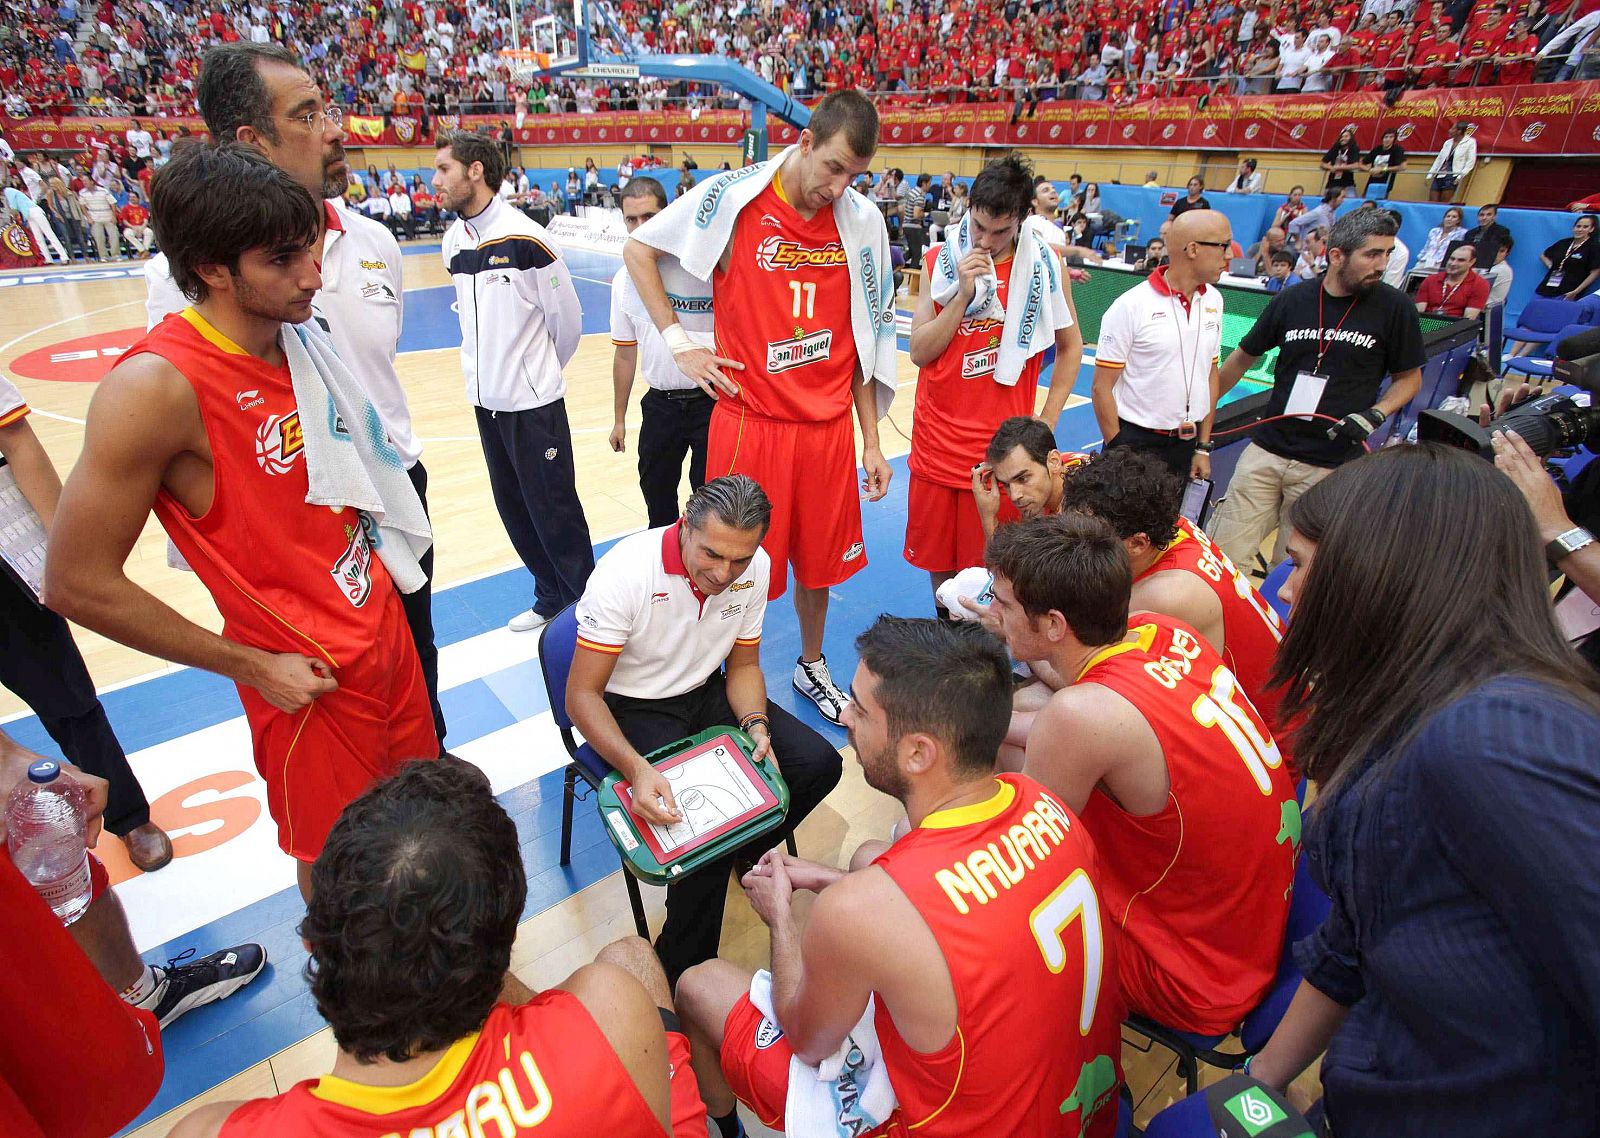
[474,399,595,616]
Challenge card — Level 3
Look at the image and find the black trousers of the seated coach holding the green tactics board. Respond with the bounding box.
[605,671,842,986]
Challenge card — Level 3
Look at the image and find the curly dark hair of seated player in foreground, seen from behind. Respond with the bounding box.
[299,759,528,1063]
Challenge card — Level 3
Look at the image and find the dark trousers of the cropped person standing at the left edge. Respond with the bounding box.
[0,573,150,837]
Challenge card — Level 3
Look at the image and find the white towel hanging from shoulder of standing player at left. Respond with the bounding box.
[282,325,434,592]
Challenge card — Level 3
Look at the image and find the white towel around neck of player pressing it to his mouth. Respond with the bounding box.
[930,214,1072,387]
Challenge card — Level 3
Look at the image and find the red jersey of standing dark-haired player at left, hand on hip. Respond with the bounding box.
[123,309,394,666]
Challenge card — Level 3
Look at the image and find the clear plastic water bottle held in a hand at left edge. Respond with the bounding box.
[5,759,90,925]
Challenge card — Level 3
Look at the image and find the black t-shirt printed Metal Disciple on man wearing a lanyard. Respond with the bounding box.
[1238,277,1426,466]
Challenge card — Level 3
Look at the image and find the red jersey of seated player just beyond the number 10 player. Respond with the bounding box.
[1139,517,1283,735]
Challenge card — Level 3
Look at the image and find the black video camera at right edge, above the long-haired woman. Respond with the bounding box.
[1416,328,1600,461]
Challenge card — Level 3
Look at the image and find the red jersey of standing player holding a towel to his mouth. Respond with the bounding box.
[910,245,1045,490]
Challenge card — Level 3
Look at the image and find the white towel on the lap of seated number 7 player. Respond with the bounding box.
[750,968,899,1138]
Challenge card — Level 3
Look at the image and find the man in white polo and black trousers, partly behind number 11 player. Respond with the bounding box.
[611,178,717,530]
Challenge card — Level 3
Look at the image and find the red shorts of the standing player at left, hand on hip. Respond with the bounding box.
[238,592,438,861]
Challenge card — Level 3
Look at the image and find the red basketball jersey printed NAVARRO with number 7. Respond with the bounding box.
[874,775,1123,1138]
